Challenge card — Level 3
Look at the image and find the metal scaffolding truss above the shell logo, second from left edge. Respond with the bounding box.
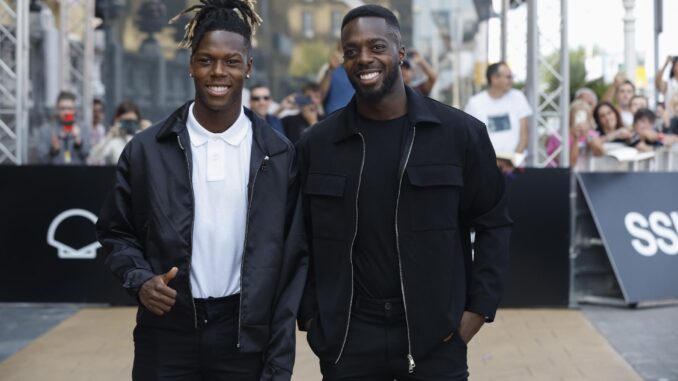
[59,0,95,135]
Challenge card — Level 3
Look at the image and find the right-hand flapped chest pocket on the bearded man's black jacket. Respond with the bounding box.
[407,164,464,231]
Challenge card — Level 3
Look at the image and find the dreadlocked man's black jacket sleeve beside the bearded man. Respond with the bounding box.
[261,149,308,381]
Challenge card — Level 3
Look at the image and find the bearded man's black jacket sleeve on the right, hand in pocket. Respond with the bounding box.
[461,118,512,322]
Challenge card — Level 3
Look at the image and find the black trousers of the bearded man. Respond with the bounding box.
[320,297,468,381]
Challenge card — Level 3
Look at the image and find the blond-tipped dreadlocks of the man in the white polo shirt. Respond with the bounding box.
[170,0,261,55]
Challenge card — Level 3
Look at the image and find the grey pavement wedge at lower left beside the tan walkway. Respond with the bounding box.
[0,303,79,362]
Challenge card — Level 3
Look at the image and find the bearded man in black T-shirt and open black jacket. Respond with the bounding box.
[297,5,511,381]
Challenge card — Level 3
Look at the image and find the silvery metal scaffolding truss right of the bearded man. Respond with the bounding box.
[527,0,576,168]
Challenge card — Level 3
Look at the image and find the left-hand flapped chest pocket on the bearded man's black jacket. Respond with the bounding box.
[304,173,347,240]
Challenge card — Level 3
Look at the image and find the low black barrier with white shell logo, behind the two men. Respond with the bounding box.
[0,166,569,307]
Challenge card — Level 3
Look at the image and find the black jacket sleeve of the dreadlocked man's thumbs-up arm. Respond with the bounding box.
[96,144,155,298]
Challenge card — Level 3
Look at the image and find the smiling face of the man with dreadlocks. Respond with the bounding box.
[190,30,252,112]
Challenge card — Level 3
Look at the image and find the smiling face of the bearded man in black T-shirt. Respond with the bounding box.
[341,17,405,102]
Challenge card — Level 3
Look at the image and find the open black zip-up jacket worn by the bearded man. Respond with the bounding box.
[297,88,511,369]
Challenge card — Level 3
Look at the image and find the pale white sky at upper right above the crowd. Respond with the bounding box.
[489,0,678,86]
